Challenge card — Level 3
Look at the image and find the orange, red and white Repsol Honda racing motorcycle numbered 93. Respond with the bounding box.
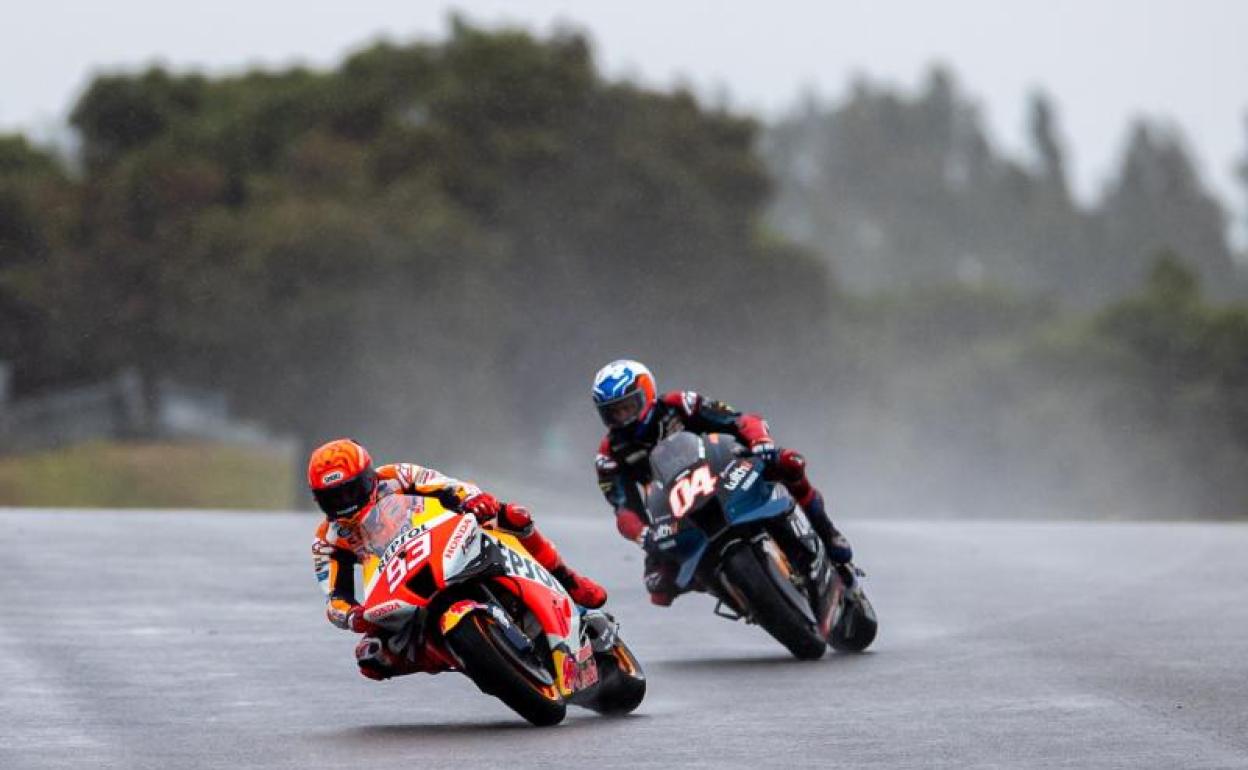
[351,494,645,725]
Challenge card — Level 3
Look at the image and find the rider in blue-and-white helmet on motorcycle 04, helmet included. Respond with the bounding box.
[593,359,854,607]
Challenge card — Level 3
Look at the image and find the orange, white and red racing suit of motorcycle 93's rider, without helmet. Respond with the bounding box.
[312,463,607,679]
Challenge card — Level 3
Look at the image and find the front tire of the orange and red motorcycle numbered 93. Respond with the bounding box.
[447,612,568,728]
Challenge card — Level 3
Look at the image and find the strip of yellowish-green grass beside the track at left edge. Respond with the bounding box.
[0,442,295,509]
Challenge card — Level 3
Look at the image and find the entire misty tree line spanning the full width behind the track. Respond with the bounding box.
[0,21,1248,515]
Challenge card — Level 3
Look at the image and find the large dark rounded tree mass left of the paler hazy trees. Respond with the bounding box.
[31,21,827,471]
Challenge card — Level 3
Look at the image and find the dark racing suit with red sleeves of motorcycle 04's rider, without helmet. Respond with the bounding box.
[595,391,854,607]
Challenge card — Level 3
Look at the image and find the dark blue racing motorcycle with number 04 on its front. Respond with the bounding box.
[645,432,879,659]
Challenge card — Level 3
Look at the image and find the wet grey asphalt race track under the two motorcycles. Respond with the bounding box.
[0,501,1248,769]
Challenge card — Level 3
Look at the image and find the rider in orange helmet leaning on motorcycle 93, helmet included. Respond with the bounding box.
[308,438,607,679]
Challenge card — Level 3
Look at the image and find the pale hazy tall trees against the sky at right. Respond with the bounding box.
[765,67,1248,307]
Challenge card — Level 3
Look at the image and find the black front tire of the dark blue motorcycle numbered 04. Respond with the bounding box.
[721,545,827,660]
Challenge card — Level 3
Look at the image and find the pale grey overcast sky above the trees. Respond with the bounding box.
[7,0,1248,234]
